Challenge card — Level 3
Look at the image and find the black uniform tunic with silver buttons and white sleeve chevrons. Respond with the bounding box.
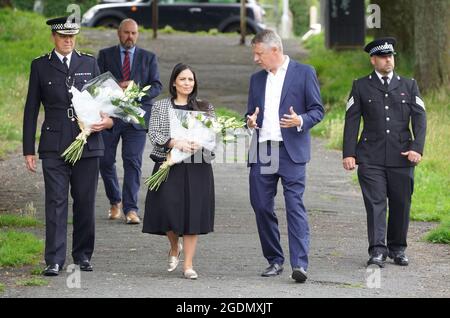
[343,71,426,167]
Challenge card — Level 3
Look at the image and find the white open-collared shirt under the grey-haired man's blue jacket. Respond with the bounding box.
[259,55,290,142]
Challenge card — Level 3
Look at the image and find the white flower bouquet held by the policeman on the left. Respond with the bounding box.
[62,72,150,165]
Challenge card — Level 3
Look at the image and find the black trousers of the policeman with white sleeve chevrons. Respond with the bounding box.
[358,164,414,255]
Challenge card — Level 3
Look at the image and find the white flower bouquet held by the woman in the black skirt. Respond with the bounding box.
[145,108,245,191]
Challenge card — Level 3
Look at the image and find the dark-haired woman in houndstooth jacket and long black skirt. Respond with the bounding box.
[142,63,215,279]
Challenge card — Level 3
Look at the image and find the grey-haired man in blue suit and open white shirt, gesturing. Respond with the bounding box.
[246,30,324,283]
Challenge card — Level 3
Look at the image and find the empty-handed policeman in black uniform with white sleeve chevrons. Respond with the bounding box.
[343,38,426,267]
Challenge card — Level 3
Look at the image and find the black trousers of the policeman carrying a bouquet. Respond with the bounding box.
[42,157,99,267]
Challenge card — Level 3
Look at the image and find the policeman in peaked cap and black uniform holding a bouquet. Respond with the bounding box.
[23,17,113,276]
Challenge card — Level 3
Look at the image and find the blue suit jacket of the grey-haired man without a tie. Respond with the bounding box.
[246,60,324,164]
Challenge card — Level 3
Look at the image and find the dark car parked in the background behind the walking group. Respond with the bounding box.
[82,0,265,33]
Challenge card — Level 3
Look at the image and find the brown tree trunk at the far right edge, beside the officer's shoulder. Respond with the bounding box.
[414,0,450,91]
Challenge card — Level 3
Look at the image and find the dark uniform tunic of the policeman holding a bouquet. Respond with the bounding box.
[23,50,104,159]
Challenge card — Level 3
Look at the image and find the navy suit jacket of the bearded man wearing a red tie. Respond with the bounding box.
[98,45,162,129]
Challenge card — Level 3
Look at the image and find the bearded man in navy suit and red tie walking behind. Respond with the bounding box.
[98,19,162,224]
